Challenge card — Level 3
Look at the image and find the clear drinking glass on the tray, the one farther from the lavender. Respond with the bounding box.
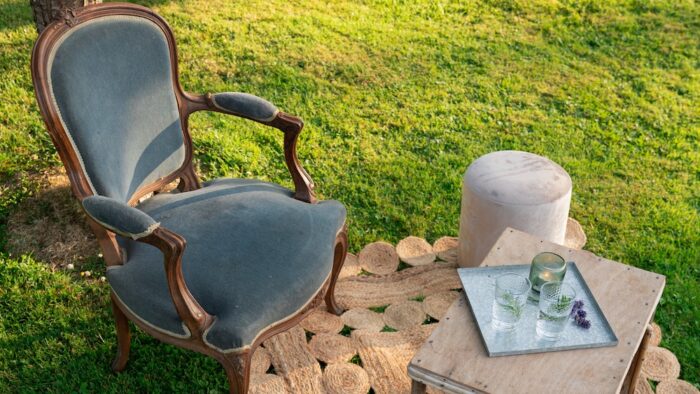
[491,273,530,330]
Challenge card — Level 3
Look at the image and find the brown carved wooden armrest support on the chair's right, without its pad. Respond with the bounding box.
[185,94,317,204]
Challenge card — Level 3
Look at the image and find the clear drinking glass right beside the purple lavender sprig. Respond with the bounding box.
[536,282,576,341]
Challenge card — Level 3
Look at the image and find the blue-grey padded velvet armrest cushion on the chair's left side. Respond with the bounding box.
[82,196,160,239]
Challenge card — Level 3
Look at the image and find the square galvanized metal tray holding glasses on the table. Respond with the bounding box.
[457,262,618,357]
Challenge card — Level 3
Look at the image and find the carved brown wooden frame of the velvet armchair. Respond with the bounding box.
[31,3,348,393]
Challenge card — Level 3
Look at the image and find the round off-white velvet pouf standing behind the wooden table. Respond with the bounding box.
[459,151,571,267]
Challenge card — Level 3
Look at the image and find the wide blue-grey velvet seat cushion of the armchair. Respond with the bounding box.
[107,179,345,351]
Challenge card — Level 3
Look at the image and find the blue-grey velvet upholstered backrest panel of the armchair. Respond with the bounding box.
[49,16,185,201]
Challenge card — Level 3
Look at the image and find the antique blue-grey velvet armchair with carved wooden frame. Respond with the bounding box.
[32,3,347,393]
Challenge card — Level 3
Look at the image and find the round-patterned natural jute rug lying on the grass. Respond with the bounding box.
[250,234,700,394]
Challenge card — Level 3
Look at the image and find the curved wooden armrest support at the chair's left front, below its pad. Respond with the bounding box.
[137,227,214,338]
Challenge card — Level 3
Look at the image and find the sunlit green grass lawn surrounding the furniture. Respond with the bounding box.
[0,0,700,392]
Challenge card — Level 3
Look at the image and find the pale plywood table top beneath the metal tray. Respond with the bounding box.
[408,229,666,393]
